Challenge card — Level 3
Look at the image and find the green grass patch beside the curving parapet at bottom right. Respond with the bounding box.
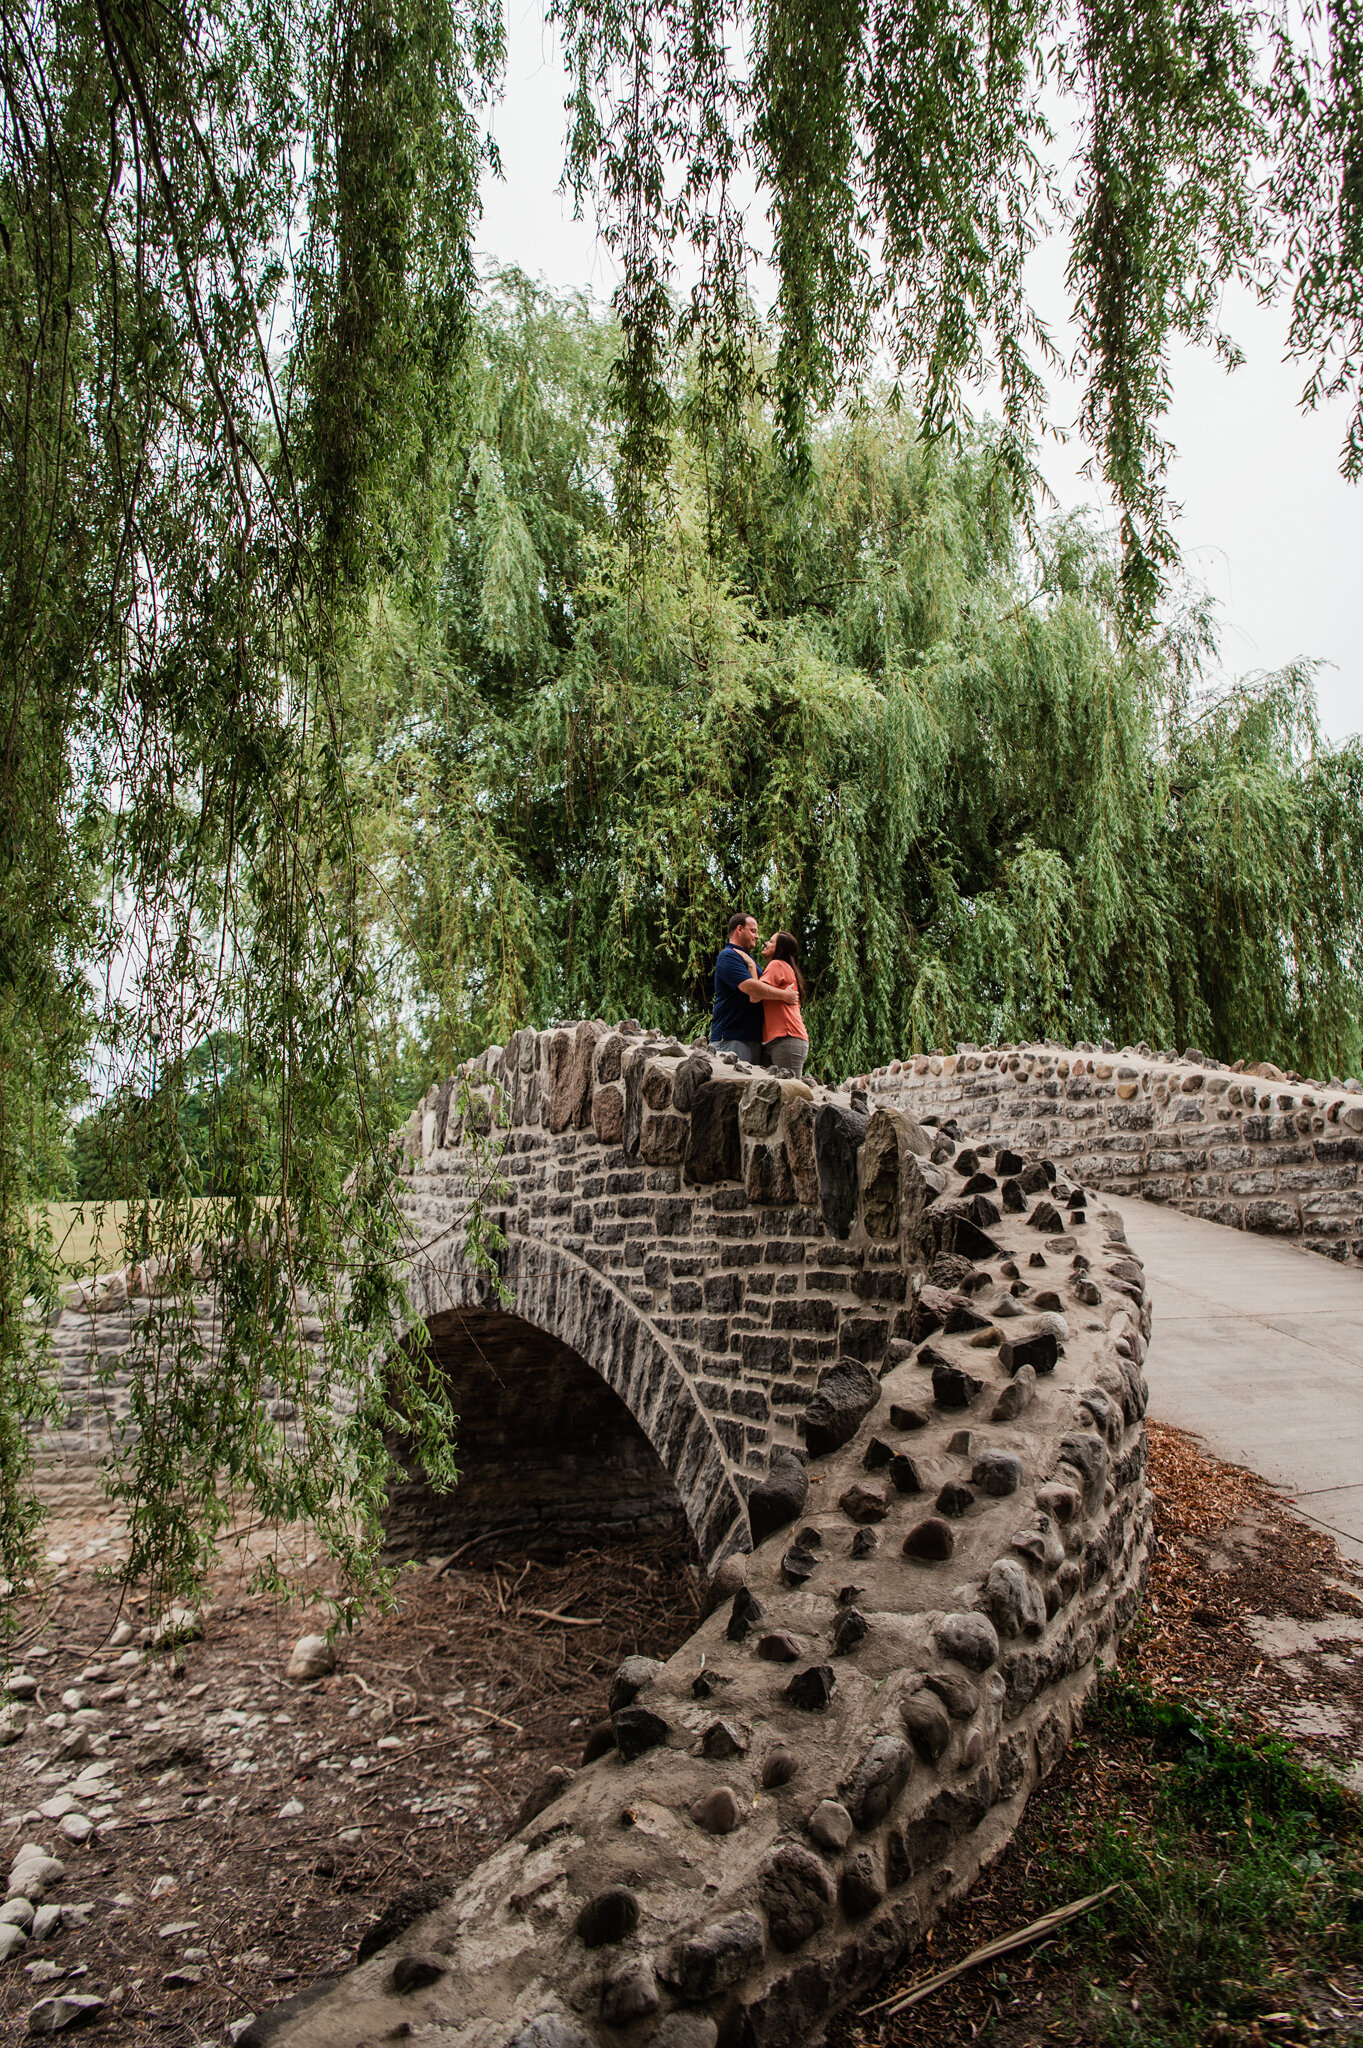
[1023,1681,1363,2048]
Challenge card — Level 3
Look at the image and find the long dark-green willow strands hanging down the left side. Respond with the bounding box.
[0,0,499,1593]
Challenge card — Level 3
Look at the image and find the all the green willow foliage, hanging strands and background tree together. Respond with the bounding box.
[0,0,1363,1589]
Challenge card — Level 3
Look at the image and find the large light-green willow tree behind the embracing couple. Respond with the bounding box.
[352,276,1363,1075]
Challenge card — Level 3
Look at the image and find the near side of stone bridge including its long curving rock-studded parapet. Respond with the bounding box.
[268,1022,1150,2048]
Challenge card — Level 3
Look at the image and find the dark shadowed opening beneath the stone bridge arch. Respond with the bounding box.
[387,1307,692,1559]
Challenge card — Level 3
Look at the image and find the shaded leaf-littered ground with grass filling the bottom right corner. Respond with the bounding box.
[831,1677,1363,2048]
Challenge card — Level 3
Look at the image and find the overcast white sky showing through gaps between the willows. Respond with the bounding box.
[479,0,1363,739]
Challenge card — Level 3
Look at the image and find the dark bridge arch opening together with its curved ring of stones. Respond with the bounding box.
[387,1241,749,1569]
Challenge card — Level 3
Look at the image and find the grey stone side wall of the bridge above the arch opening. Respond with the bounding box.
[392,1022,931,1565]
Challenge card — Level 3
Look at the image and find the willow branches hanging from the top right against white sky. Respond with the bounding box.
[553,0,1363,623]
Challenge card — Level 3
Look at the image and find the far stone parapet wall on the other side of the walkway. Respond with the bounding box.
[855,1044,1363,1260]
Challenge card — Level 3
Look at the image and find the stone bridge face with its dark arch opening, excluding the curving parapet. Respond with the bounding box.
[391,1024,945,1569]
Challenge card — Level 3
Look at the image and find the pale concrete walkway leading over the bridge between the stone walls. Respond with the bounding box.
[1101,1196,1363,1561]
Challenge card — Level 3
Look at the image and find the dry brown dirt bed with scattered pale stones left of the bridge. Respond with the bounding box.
[0,1538,702,2048]
